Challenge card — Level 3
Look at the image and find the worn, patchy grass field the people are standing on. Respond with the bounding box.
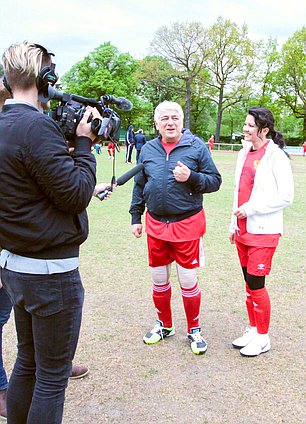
[4,148,306,424]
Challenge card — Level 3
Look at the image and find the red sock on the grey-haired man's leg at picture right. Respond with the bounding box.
[181,282,201,333]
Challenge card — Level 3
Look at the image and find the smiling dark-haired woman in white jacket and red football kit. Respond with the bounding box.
[229,107,294,356]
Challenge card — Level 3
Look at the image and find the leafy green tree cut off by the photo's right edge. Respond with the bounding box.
[272,27,306,140]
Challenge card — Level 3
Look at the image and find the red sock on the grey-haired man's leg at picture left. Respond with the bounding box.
[153,282,172,328]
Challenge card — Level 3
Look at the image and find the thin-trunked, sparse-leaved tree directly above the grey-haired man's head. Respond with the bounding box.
[151,22,207,128]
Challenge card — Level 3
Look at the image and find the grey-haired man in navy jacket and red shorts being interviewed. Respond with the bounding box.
[130,101,221,355]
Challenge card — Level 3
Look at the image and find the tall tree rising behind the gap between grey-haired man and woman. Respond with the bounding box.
[202,17,255,142]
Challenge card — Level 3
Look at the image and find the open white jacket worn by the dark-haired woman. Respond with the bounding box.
[230,140,294,234]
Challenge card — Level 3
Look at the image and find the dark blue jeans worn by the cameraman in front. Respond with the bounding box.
[2,269,84,424]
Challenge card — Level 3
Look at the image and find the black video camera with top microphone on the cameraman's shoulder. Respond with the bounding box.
[43,85,133,143]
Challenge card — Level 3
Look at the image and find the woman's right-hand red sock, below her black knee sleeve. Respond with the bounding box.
[250,287,271,334]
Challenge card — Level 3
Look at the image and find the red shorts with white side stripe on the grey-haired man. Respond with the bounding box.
[147,234,204,269]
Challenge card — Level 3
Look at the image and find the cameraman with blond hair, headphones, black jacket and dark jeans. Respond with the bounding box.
[0,42,106,424]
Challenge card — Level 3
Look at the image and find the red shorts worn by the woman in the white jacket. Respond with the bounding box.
[236,240,276,276]
